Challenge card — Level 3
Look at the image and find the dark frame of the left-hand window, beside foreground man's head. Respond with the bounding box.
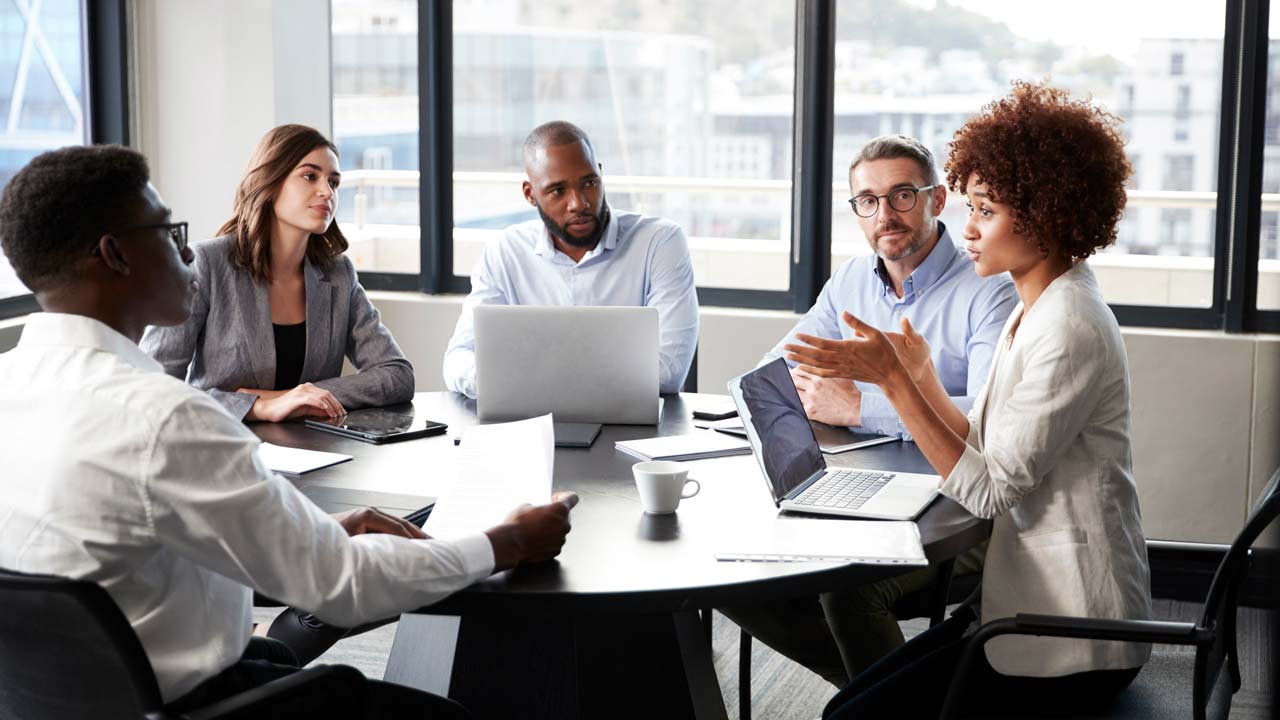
[0,0,129,320]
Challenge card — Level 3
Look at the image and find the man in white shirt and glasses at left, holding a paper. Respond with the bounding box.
[0,146,577,714]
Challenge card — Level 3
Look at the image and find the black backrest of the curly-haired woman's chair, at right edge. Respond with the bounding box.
[1193,470,1280,708]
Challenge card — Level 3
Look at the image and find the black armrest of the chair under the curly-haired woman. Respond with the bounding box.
[940,614,1213,720]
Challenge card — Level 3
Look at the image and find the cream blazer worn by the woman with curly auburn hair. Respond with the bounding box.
[941,263,1151,678]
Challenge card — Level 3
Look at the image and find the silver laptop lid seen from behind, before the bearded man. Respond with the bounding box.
[475,305,659,425]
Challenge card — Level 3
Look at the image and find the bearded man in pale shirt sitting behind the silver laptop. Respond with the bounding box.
[444,120,698,397]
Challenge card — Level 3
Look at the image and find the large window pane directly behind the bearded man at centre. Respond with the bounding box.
[453,0,795,291]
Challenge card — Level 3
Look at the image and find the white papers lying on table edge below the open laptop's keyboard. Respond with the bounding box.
[716,516,929,566]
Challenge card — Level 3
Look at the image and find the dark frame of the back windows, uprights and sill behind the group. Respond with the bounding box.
[361,0,1280,333]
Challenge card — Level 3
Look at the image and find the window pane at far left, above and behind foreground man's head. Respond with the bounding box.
[0,0,88,299]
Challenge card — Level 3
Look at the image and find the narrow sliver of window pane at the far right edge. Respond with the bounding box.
[1258,18,1280,310]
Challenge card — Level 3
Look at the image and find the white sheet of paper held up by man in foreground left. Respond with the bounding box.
[422,415,556,538]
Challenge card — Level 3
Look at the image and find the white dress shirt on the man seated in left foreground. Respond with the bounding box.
[0,314,493,702]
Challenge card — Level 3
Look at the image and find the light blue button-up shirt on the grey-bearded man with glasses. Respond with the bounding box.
[760,223,1018,439]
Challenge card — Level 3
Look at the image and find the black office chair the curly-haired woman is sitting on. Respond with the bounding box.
[942,470,1280,720]
